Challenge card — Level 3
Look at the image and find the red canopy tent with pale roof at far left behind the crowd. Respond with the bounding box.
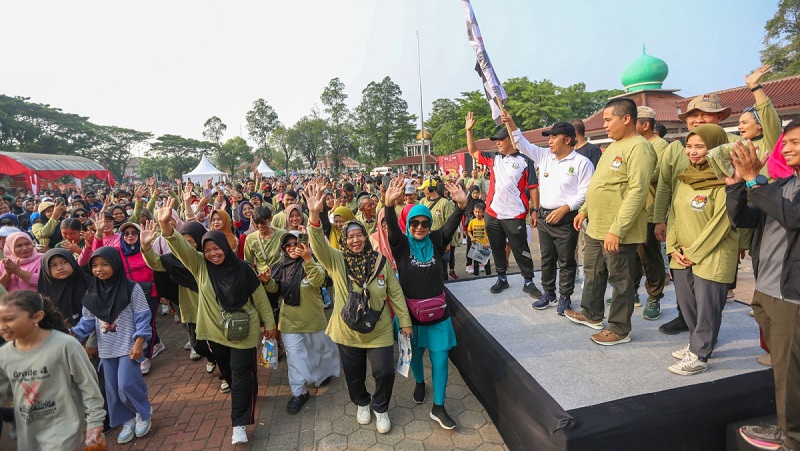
[0,152,114,194]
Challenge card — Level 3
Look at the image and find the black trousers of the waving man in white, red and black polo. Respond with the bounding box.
[485,215,533,279]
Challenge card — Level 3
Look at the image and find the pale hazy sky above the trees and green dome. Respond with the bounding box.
[0,0,777,149]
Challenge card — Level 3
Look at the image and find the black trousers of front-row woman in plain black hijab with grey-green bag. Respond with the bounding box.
[208,341,258,426]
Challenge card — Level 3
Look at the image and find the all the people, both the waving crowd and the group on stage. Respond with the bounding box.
[0,66,800,449]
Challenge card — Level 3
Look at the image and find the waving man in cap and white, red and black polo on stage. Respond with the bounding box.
[464,111,542,299]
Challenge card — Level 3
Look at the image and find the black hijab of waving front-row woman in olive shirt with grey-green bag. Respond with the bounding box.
[201,230,261,312]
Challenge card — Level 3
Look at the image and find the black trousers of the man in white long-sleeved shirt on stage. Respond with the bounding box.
[536,217,578,296]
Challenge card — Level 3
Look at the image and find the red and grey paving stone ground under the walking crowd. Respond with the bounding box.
[0,238,753,451]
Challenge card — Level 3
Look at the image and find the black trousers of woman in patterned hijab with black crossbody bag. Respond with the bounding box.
[338,344,394,413]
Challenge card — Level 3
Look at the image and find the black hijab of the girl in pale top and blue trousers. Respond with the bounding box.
[83,246,136,324]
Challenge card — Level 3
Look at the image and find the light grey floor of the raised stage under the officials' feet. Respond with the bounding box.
[447,274,765,410]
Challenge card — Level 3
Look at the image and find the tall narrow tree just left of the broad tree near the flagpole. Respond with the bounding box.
[320,77,355,174]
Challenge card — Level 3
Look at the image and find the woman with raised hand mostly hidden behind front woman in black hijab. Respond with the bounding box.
[141,221,217,380]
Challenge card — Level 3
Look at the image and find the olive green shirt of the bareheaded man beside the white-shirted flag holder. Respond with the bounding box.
[580,135,656,244]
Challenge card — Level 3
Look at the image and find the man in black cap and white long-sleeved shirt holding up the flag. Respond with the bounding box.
[501,115,594,315]
